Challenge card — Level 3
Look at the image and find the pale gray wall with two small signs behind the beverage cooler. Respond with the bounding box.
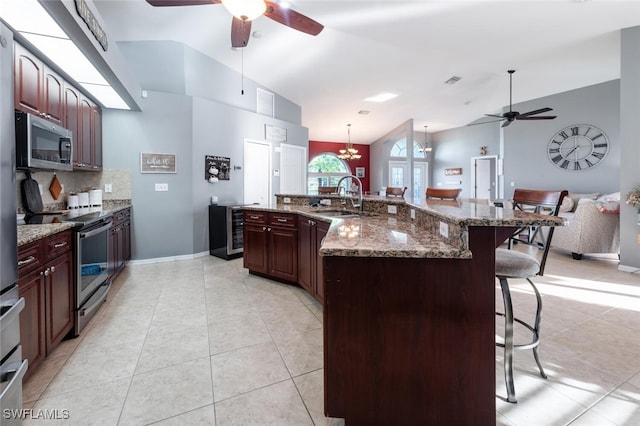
[103,42,309,260]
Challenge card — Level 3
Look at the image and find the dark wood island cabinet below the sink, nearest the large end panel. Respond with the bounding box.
[298,215,330,303]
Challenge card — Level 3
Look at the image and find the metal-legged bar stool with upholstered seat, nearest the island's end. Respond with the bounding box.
[496,189,568,403]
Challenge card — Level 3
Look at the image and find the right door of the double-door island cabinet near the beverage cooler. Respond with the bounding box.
[269,227,298,282]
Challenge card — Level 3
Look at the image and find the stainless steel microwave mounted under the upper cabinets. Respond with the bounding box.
[16,111,73,170]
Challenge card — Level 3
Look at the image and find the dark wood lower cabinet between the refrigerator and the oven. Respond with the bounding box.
[18,231,73,376]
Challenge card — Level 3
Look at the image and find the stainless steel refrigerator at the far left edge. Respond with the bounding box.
[0,21,28,426]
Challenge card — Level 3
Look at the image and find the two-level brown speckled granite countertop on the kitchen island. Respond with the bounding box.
[250,194,564,259]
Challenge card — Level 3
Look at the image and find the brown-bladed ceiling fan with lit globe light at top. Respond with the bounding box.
[147,0,324,47]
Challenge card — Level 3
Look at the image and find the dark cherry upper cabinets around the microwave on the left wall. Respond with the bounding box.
[14,43,102,171]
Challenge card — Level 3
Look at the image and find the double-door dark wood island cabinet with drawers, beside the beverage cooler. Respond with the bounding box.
[243,211,298,283]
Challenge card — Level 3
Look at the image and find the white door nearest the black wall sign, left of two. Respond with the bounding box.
[244,139,272,207]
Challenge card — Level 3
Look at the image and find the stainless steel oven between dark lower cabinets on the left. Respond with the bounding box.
[74,212,112,336]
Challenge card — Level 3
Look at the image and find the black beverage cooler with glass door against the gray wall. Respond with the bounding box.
[209,204,243,260]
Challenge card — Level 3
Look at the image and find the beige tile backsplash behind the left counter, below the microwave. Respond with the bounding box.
[16,169,131,212]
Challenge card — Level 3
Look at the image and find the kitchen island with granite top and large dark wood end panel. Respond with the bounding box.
[242,195,563,425]
